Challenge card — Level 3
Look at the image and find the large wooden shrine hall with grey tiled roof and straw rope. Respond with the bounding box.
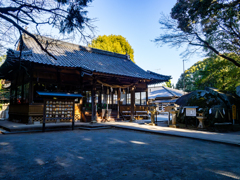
[0,34,171,123]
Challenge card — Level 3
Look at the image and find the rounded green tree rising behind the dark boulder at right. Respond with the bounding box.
[176,54,240,92]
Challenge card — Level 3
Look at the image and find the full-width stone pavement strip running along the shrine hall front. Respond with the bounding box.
[0,121,240,146]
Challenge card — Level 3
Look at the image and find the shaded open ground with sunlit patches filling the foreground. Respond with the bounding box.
[0,128,240,180]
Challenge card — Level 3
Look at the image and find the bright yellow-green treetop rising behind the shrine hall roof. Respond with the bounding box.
[89,35,135,63]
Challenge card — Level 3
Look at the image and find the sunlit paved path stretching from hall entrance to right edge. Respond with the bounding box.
[105,122,240,146]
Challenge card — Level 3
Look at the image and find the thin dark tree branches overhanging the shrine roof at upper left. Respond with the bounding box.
[0,0,93,56]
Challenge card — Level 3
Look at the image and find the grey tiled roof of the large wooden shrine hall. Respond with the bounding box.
[5,35,171,82]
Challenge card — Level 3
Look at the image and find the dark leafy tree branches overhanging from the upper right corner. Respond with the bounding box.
[155,0,240,67]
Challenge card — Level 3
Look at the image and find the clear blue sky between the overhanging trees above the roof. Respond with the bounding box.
[84,0,203,84]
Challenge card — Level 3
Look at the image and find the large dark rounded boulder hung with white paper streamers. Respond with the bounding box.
[176,87,240,128]
